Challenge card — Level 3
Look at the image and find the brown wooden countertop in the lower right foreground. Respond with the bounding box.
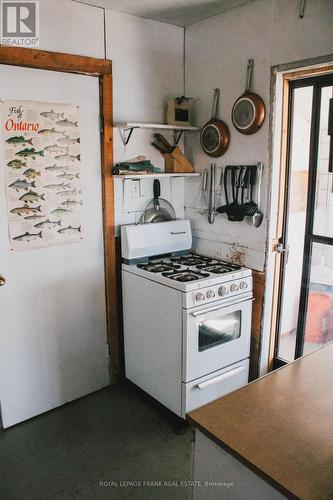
[188,343,333,500]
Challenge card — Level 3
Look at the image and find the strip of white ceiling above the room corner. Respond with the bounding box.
[73,0,253,26]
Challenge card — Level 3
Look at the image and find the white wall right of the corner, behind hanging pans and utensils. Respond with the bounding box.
[186,0,333,270]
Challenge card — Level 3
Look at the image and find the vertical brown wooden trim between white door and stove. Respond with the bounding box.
[100,75,120,384]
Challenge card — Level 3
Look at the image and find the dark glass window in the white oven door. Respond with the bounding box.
[199,311,242,351]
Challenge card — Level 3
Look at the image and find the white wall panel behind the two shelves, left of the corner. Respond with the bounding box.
[106,10,184,170]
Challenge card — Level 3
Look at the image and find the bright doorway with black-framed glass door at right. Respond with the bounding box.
[273,73,333,368]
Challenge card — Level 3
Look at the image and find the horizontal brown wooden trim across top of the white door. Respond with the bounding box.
[0,45,112,76]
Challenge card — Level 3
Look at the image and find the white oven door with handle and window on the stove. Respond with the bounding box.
[182,293,253,382]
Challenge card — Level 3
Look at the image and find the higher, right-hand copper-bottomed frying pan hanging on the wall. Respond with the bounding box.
[231,59,266,135]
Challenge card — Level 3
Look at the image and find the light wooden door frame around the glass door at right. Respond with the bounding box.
[268,64,333,371]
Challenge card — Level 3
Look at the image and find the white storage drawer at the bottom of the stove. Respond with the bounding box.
[182,359,249,417]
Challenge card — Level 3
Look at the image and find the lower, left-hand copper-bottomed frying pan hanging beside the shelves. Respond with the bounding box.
[200,89,230,158]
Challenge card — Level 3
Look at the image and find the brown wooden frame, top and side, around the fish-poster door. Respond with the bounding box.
[0,46,120,384]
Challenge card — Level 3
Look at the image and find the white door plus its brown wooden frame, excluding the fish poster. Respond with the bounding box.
[0,46,119,429]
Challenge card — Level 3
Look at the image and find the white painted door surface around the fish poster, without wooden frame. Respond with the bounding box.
[0,66,108,428]
